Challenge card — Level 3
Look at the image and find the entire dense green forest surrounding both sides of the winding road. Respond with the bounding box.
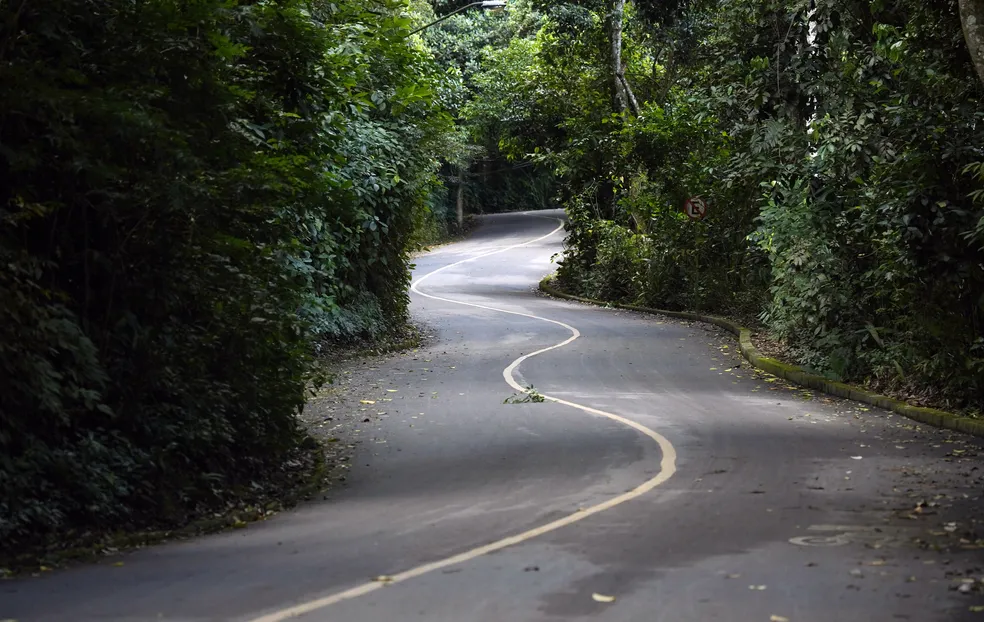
[0,0,984,544]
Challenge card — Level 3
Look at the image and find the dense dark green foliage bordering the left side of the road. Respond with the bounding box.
[0,0,451,547]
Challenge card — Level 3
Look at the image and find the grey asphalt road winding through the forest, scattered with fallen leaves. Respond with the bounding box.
[0,212,984,622]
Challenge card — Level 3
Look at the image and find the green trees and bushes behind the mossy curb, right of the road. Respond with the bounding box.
[465,0,984,410]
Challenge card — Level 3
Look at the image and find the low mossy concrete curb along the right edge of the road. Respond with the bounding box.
[540,275,984,437]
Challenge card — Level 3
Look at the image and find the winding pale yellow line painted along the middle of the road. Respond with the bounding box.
[250,216,676,622]
